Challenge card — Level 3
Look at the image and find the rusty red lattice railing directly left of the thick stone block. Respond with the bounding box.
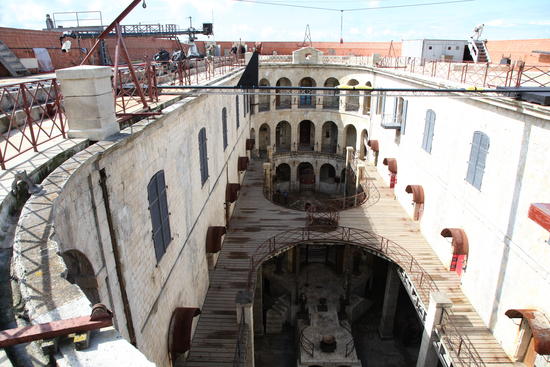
[0,78,66,169]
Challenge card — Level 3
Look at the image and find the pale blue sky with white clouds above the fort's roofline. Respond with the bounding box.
[0,0,550,42]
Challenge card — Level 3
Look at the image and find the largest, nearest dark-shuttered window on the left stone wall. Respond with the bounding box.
[147,170,172,263]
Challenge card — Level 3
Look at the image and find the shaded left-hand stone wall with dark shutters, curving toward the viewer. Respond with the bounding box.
[14,70,249,365]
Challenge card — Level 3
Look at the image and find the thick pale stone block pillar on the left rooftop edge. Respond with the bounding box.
[55,65,120,141]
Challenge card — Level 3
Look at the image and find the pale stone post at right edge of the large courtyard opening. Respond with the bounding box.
[416,292,453,367]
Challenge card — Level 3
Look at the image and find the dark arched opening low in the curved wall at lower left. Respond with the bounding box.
[61,250,100,305]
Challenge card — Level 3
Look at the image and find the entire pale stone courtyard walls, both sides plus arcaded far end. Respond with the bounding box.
[10,56,550,365]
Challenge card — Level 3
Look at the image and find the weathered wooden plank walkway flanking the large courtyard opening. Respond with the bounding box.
[185,160,513,367]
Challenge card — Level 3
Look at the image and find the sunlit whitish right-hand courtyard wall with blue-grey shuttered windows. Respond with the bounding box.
[371,70,550,360]
